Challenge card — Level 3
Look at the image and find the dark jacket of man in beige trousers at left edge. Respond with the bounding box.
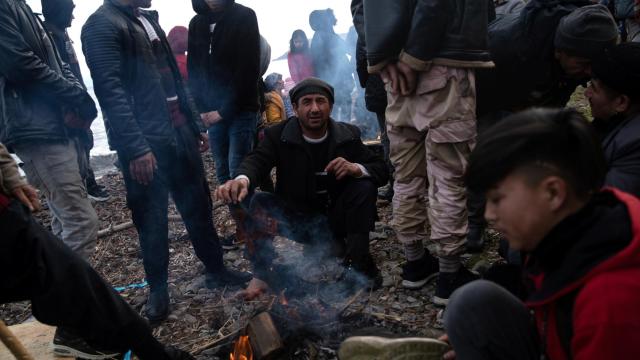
[0,0,95,146]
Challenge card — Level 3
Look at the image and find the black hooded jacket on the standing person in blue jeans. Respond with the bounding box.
[187,0,260,118]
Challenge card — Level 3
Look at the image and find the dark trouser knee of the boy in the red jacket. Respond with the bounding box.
[444,280,540,360]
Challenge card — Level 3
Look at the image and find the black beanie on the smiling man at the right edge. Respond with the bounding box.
[591,43,640,97]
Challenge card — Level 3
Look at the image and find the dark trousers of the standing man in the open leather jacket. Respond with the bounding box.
[119,125,224,291]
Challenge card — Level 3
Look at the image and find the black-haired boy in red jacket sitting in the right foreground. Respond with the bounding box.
[341,109,640,360]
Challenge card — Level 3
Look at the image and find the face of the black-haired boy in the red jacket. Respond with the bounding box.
[484,172,557,251]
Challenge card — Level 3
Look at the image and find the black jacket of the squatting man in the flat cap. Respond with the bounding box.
[238,117,389,212]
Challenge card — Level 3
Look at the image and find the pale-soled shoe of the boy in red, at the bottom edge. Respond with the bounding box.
[338,336,450,360]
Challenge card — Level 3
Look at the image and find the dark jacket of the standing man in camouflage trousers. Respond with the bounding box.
[364,0,492,72]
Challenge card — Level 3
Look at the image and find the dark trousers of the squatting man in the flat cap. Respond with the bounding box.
[249,179,377,277]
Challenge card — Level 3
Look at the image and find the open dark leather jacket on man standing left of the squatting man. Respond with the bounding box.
[82,0,202,161]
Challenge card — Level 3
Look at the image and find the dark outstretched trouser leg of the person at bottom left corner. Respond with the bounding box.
[0,201,168,359]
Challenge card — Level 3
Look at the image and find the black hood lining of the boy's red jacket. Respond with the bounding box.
[525,189,640,306]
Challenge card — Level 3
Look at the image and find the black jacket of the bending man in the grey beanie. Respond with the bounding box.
[476,0,591,118]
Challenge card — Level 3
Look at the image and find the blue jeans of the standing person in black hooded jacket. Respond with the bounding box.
[209,112,258,184]
